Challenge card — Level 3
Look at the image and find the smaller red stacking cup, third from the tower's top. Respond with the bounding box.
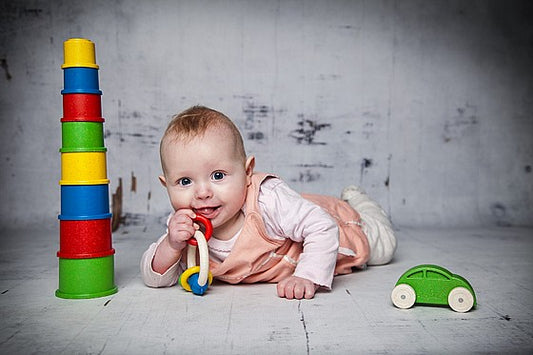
[61,94,104,122]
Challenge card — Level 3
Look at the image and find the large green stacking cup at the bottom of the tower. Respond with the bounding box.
[56,255,118,299]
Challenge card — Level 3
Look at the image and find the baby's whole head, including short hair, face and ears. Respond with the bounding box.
[160,106,254,232]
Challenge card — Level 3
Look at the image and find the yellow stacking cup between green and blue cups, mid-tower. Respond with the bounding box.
[59,152,109,185]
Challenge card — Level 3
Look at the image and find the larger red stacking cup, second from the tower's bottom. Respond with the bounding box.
[57,218,115,259]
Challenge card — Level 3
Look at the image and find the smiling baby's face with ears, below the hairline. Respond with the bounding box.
[161,129,253,234]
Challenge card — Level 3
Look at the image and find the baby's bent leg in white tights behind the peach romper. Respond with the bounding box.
[341,185,396,265]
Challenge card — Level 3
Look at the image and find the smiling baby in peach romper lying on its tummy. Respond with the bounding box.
[141,106,396,299]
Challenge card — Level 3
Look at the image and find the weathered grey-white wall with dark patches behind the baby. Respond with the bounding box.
[0,0,533,227]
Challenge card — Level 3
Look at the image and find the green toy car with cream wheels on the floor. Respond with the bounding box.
[391,264,476,312]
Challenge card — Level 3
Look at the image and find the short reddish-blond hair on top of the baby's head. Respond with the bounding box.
[159,106,246,161]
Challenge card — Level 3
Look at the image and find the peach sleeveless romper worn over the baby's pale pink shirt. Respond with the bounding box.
[210,173,370,284]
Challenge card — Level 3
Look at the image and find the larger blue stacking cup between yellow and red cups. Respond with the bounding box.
[59,184,111,221]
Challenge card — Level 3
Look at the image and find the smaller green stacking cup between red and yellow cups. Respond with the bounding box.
[60,121,106,153]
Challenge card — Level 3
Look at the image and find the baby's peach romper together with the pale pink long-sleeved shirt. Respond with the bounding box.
[141,173,370,288]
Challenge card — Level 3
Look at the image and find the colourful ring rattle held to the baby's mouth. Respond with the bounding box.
[178,215,213,296]
